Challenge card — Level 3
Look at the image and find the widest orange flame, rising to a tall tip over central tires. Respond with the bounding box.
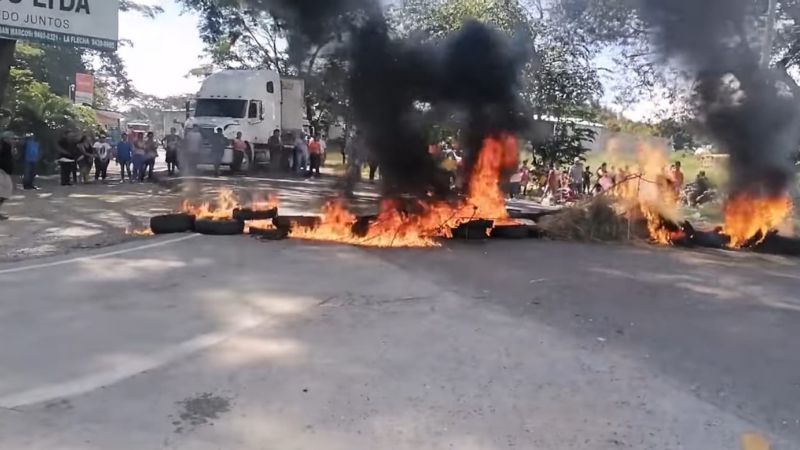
[291,136,519,247]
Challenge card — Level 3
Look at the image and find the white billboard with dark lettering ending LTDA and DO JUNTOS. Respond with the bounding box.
[0,0,119,50]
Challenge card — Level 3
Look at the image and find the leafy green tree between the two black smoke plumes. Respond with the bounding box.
[389,0,602,162]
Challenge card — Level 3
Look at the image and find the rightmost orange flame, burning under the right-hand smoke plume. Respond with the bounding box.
[723,194,792,248]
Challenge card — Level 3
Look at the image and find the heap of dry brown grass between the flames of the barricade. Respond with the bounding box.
[539,195,629,241]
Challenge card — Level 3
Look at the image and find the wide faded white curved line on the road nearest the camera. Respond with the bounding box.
[0,318,264,409]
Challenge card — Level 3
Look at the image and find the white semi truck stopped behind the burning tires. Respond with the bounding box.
[186,70,308,170]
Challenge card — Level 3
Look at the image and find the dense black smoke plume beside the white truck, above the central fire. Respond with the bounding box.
[247,0,526,195]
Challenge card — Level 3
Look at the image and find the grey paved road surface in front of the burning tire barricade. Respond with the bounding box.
[0,236,800,450]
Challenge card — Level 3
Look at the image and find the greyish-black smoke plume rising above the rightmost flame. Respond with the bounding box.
[641,0,800,196]
